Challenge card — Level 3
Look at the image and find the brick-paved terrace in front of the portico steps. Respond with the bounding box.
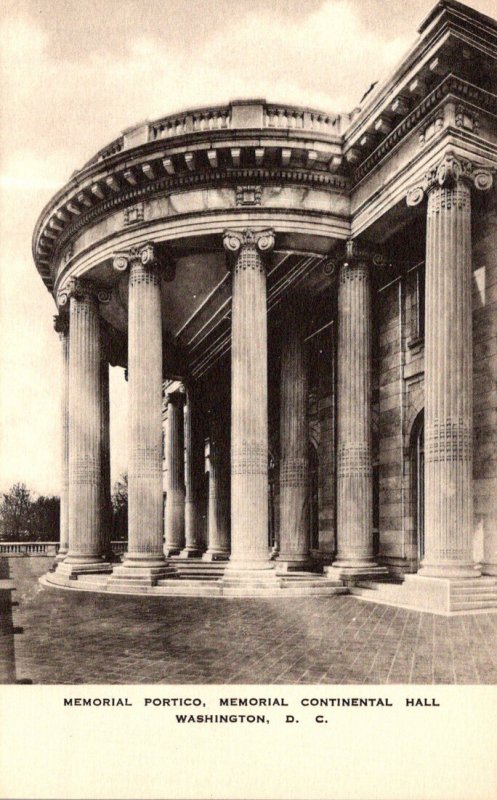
[0,558,497,684]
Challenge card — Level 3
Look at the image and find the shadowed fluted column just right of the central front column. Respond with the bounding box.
[277,298,309,570]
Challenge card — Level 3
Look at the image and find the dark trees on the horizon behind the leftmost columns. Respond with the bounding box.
[0,475,128,542]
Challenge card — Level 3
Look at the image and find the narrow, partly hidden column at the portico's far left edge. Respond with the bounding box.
[54,314,69,562]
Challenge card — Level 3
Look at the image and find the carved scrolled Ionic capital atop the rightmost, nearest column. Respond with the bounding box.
[406,152,493,206]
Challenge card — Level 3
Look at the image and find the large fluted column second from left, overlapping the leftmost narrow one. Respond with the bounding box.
[58,279,109,575]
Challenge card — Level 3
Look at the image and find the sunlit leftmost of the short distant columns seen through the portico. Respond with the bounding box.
[164,392,185,556]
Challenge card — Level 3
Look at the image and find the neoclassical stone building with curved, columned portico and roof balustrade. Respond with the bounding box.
[33,0,497,613]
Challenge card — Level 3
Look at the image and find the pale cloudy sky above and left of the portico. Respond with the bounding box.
[0,0,497,493]
